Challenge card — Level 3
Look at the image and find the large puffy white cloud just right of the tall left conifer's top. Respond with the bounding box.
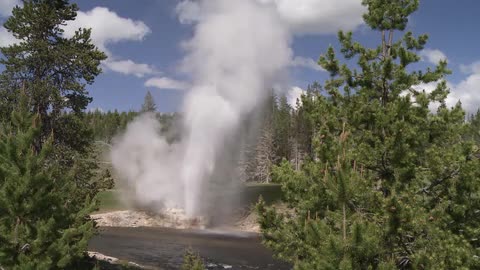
[63,7,151,53]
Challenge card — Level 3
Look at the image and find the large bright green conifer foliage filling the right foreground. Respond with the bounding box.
[258,0,480,269]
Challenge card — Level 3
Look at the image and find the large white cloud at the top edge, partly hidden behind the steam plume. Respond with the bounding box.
[177,0,365,35]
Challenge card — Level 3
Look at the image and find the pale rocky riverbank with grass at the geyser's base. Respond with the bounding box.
[92,183,281,233]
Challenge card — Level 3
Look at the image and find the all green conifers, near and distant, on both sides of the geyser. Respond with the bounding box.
[0,0,480,270]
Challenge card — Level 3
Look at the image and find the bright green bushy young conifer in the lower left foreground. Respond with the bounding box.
[0,98,96,269]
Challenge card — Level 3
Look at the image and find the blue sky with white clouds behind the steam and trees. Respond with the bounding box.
[0,0,480,112]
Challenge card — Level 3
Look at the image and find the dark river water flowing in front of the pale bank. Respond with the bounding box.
[89,228,292,270]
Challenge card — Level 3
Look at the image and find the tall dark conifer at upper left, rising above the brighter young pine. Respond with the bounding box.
[0,0,106,148]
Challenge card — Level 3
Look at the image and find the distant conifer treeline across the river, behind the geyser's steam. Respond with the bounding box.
[84,83,480,187]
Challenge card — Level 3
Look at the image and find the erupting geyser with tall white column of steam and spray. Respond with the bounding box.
[111,0,292,216]
